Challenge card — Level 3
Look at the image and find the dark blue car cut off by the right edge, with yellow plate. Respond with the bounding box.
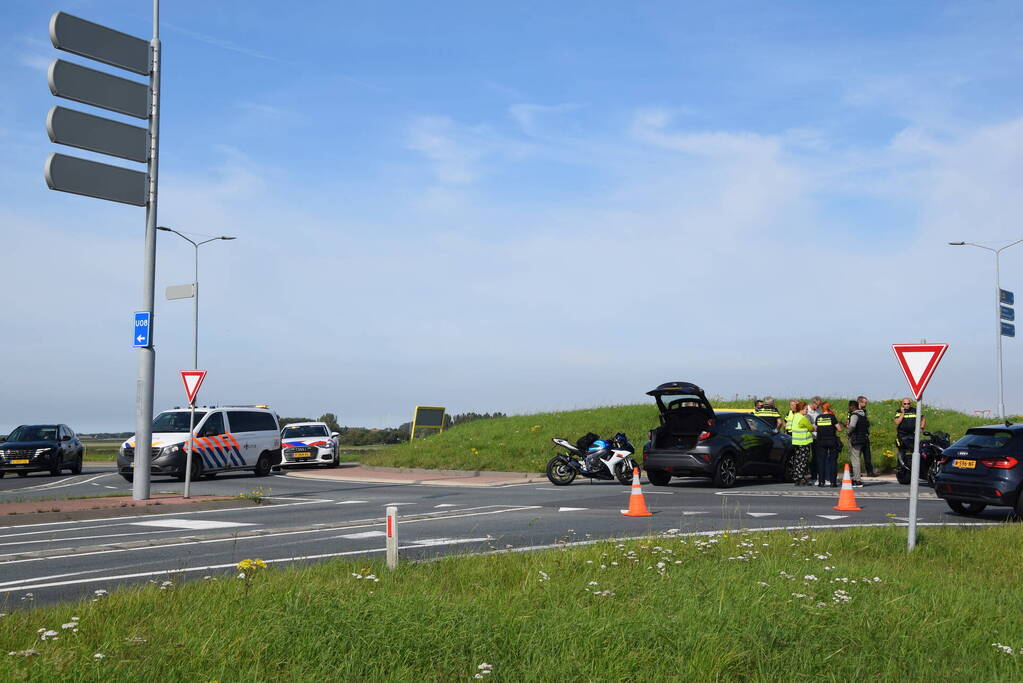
[934,424,1023,516]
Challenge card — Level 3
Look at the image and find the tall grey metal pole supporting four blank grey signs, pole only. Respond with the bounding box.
[132,0,161,500]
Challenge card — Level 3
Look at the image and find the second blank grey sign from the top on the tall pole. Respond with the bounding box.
[47,59,149,119]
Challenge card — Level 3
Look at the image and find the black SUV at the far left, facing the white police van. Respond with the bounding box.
[0,424,85,477]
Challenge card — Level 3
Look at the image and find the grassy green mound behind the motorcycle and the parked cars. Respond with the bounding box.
[360,399,990,472]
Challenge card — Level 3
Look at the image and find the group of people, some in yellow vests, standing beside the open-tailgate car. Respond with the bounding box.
[753,396,876,488]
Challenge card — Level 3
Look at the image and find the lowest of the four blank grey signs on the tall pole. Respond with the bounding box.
[45,154,147,207]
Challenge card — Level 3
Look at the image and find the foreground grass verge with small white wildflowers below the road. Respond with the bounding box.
[0,525,1023,682]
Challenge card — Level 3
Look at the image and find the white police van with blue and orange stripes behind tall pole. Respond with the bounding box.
[118,406,280,482]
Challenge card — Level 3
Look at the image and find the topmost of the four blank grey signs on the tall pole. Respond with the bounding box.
[50,12,149,76]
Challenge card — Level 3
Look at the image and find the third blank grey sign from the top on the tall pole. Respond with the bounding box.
[46,106,149,164]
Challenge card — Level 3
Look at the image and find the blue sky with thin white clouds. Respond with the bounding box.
[0,0,1023,431]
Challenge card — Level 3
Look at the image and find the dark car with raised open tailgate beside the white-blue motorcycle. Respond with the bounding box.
[642,381,792,489]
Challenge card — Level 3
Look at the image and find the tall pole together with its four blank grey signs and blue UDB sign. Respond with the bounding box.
[44,5,163,500]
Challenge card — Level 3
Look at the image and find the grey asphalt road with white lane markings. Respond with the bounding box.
[0,465,1009,611]
